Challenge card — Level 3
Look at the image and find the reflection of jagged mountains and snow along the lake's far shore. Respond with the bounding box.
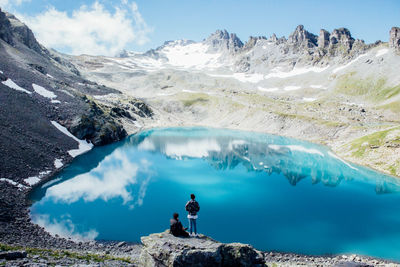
[129,128,400,194]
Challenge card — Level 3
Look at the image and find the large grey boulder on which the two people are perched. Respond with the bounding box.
[139,230,265,267]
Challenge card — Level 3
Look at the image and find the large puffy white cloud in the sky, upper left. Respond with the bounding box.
[16,0,152,56]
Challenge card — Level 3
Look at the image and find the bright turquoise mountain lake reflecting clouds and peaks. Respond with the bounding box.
[31,128,400,261]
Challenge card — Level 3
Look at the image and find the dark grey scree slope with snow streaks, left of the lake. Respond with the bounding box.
[0,7,150,186]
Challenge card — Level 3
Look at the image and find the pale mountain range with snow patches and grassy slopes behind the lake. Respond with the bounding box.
[69,25,400,178]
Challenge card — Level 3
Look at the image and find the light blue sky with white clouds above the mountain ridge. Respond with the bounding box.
[0,0,400,56]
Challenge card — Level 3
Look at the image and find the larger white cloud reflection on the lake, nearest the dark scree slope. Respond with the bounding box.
[46,150,151,208]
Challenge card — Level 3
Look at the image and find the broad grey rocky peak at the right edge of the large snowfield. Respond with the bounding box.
[205,30,243,52]
